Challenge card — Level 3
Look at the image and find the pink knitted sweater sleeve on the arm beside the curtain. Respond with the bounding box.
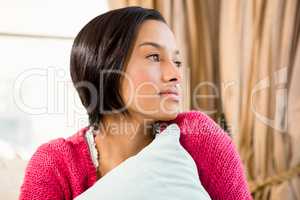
[168,110,251,199]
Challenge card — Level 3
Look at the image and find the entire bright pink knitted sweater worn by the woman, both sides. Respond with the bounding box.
[19,111,252,200]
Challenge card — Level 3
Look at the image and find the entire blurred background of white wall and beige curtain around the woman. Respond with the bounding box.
[0,0,300,200]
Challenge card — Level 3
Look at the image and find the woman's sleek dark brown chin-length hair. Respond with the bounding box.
[70,7,166,129]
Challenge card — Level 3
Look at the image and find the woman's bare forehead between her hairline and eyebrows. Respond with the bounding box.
[135,20,177,50]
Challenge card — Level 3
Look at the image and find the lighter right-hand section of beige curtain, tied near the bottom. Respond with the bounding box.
[220,0,300,200]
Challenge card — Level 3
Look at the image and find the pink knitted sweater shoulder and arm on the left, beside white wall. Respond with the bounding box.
[20,128,96,199]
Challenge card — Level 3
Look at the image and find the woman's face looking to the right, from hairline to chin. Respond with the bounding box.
[121,20,182,121]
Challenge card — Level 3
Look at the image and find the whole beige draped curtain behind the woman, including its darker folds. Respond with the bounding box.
[106,0,300,200]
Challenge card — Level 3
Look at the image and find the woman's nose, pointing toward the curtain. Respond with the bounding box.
[162,61,182,84]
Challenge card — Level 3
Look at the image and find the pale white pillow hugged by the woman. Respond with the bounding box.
[76,123,210,200]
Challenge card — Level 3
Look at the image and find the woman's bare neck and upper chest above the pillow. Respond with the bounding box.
[96,114,154,171]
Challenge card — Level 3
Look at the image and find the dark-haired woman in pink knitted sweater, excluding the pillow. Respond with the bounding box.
[20,7,251,200]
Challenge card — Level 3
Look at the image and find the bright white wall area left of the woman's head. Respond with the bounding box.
[0,0,108,159]
